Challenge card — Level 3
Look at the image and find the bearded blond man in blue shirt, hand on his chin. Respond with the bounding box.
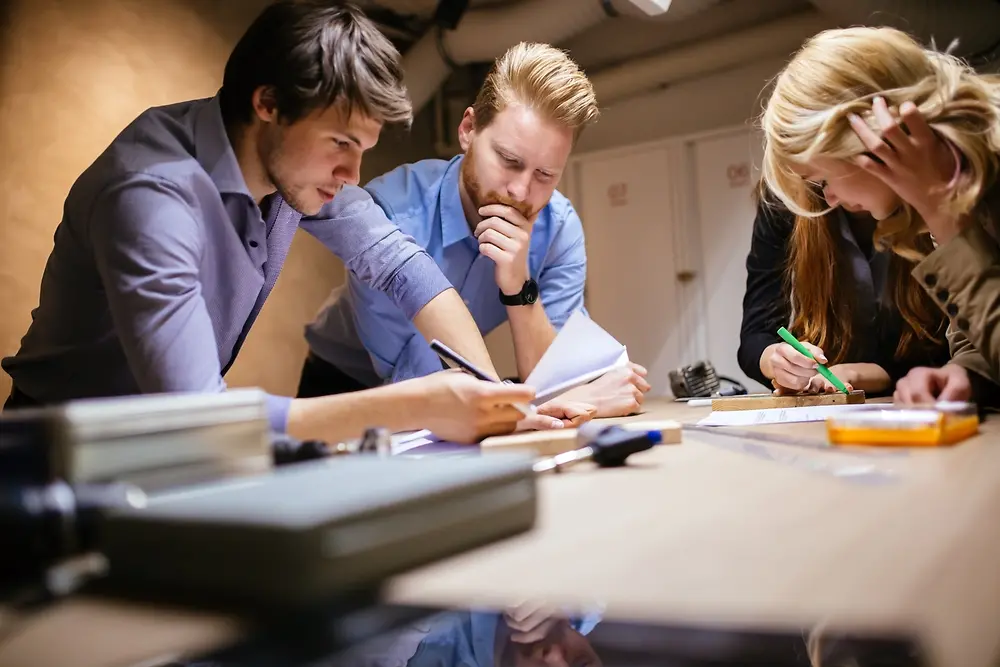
[299,43,649,417]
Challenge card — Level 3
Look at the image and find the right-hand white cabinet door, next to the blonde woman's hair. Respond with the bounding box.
[693,131,761,391]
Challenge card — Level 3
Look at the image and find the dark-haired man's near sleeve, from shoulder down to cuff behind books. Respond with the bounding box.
[87,175,290,431]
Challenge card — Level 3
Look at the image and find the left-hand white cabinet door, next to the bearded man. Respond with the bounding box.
[574,147,681,395]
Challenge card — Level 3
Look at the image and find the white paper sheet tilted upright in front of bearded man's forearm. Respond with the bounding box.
[524,310,629,404]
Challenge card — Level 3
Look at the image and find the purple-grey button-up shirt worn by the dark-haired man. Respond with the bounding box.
[2,97,451,431]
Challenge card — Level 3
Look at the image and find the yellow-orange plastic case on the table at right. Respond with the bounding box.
[826,402,979,447]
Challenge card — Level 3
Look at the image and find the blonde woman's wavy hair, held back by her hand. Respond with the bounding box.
[761,27,1000,261]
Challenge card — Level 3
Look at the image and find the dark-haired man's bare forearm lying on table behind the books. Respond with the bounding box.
[287,383,426,443]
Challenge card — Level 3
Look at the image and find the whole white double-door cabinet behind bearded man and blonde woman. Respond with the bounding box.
[563,130,760,395]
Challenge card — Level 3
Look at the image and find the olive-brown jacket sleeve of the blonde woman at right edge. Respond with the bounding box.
[913,221,1000,383]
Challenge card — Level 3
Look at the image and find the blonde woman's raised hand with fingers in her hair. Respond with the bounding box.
[849,97,965,245]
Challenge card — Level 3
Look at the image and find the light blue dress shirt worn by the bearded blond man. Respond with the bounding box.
[306,156,587,386]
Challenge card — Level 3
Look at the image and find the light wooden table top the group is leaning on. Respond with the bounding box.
[0,401,1000,667]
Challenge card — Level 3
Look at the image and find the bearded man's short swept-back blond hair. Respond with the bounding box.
[472,42,600,140]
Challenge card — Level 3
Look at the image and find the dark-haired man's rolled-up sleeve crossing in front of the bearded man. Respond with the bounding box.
[299,186,452,320]
